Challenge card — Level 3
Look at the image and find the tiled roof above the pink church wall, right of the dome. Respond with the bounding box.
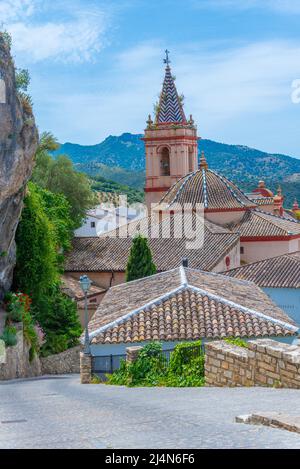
[230,209,300,237]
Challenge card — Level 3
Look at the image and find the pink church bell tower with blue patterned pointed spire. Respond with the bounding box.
[143,50,198,210]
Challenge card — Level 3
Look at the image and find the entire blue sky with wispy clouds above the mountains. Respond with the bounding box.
[0,0,300,157]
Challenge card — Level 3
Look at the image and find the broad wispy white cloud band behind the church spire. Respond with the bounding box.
[37,41,300,143]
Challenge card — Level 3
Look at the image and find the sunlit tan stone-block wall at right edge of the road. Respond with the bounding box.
[205,339,300,389]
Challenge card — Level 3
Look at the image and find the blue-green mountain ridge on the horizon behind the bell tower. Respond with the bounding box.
[53,132,300,206]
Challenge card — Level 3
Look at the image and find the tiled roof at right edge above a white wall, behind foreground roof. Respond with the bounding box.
[224,251,300,288]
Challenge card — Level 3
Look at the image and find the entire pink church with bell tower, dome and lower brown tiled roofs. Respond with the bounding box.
[65,53,300,290]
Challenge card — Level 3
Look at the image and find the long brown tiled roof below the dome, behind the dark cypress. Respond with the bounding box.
[65,215,239,272]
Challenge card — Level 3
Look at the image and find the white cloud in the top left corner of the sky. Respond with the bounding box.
[0,0,108,63]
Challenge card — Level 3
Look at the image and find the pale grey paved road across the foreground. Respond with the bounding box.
[0,375,300,448]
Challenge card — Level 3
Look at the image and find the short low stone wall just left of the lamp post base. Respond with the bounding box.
[40,345,81,375]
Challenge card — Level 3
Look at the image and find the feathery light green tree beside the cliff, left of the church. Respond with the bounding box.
[32,133,97,228]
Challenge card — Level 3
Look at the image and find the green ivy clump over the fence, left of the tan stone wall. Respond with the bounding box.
[107,341,204,387]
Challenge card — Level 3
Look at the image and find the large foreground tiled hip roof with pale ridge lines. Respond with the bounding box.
[89,267,298,344]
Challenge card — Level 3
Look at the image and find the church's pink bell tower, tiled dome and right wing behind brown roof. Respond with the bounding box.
[143,54,300,263]
